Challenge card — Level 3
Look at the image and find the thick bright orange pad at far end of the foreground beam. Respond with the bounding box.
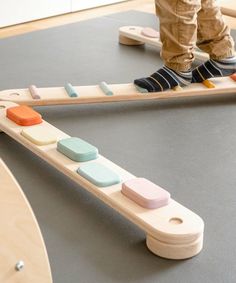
[7,105,42,126]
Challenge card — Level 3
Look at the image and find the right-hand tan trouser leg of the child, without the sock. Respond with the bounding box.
[197,0,234,59]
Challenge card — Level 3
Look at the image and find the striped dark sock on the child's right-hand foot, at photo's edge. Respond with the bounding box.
[192,56,236,83]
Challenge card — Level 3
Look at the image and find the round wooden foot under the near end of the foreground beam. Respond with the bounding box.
[146,234,203,259]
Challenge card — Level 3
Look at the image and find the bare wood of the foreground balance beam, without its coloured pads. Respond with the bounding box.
[0,101,204,259]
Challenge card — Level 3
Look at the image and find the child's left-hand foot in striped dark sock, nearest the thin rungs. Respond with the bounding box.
[134,66,192,92]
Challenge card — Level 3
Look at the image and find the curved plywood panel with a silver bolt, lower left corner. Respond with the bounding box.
[0,159,52,283]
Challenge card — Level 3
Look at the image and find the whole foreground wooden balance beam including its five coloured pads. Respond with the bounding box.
[0,101,204,260]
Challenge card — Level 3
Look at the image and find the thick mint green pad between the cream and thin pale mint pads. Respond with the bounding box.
[57,138,98,162]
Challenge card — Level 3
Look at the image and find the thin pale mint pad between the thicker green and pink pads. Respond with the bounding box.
[77,162,121,187]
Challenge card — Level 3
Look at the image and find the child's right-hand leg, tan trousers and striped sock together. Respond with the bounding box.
[193,0,236,82]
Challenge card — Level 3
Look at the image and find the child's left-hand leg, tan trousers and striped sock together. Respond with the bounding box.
[134,0,201,92]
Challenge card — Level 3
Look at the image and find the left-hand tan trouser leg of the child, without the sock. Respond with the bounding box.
[155,0,201,71]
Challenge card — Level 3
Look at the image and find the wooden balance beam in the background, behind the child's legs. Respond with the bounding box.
[119,26,236,61]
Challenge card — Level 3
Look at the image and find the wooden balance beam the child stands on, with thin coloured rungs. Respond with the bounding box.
[0,77,236,106]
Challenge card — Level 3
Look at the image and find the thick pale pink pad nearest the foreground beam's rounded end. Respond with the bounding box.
[121,178,170,209]
